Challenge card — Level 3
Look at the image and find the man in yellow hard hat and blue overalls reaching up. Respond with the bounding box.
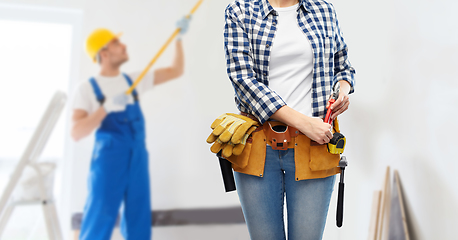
[71,18,189,240]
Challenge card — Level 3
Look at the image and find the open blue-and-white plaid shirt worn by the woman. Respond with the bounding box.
[224,0,355,123]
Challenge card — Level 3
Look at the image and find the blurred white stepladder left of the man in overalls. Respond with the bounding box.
[0,91,67,240]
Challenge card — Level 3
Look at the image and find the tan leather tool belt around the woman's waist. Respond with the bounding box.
[214,113,340,180]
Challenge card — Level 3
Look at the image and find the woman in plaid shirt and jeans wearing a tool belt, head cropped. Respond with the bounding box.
[224,0,355,240]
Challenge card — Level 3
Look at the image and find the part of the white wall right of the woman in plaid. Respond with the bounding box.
[329,0,458,239]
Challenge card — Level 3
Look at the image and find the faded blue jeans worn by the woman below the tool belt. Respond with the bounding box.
[235,146,335,240]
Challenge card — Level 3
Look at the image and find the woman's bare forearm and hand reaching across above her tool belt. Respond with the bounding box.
[271,106,332,144]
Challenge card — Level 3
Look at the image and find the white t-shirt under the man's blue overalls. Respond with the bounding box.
[73,72,153,114]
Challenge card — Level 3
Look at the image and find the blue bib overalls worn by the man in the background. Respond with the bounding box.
[80,74,152,240]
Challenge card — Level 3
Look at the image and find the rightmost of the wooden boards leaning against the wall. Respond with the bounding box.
[388,170,410,240]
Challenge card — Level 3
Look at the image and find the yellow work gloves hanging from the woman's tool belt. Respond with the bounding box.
[207,113,259,157]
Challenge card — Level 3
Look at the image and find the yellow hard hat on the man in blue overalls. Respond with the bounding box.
[86,28,122,62]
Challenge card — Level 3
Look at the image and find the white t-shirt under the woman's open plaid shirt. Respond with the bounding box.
[269,4,313,117]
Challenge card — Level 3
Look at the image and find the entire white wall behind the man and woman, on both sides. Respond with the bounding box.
[0,0,458,239]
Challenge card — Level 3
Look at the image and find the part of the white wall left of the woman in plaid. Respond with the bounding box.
[0,0,239,238]
